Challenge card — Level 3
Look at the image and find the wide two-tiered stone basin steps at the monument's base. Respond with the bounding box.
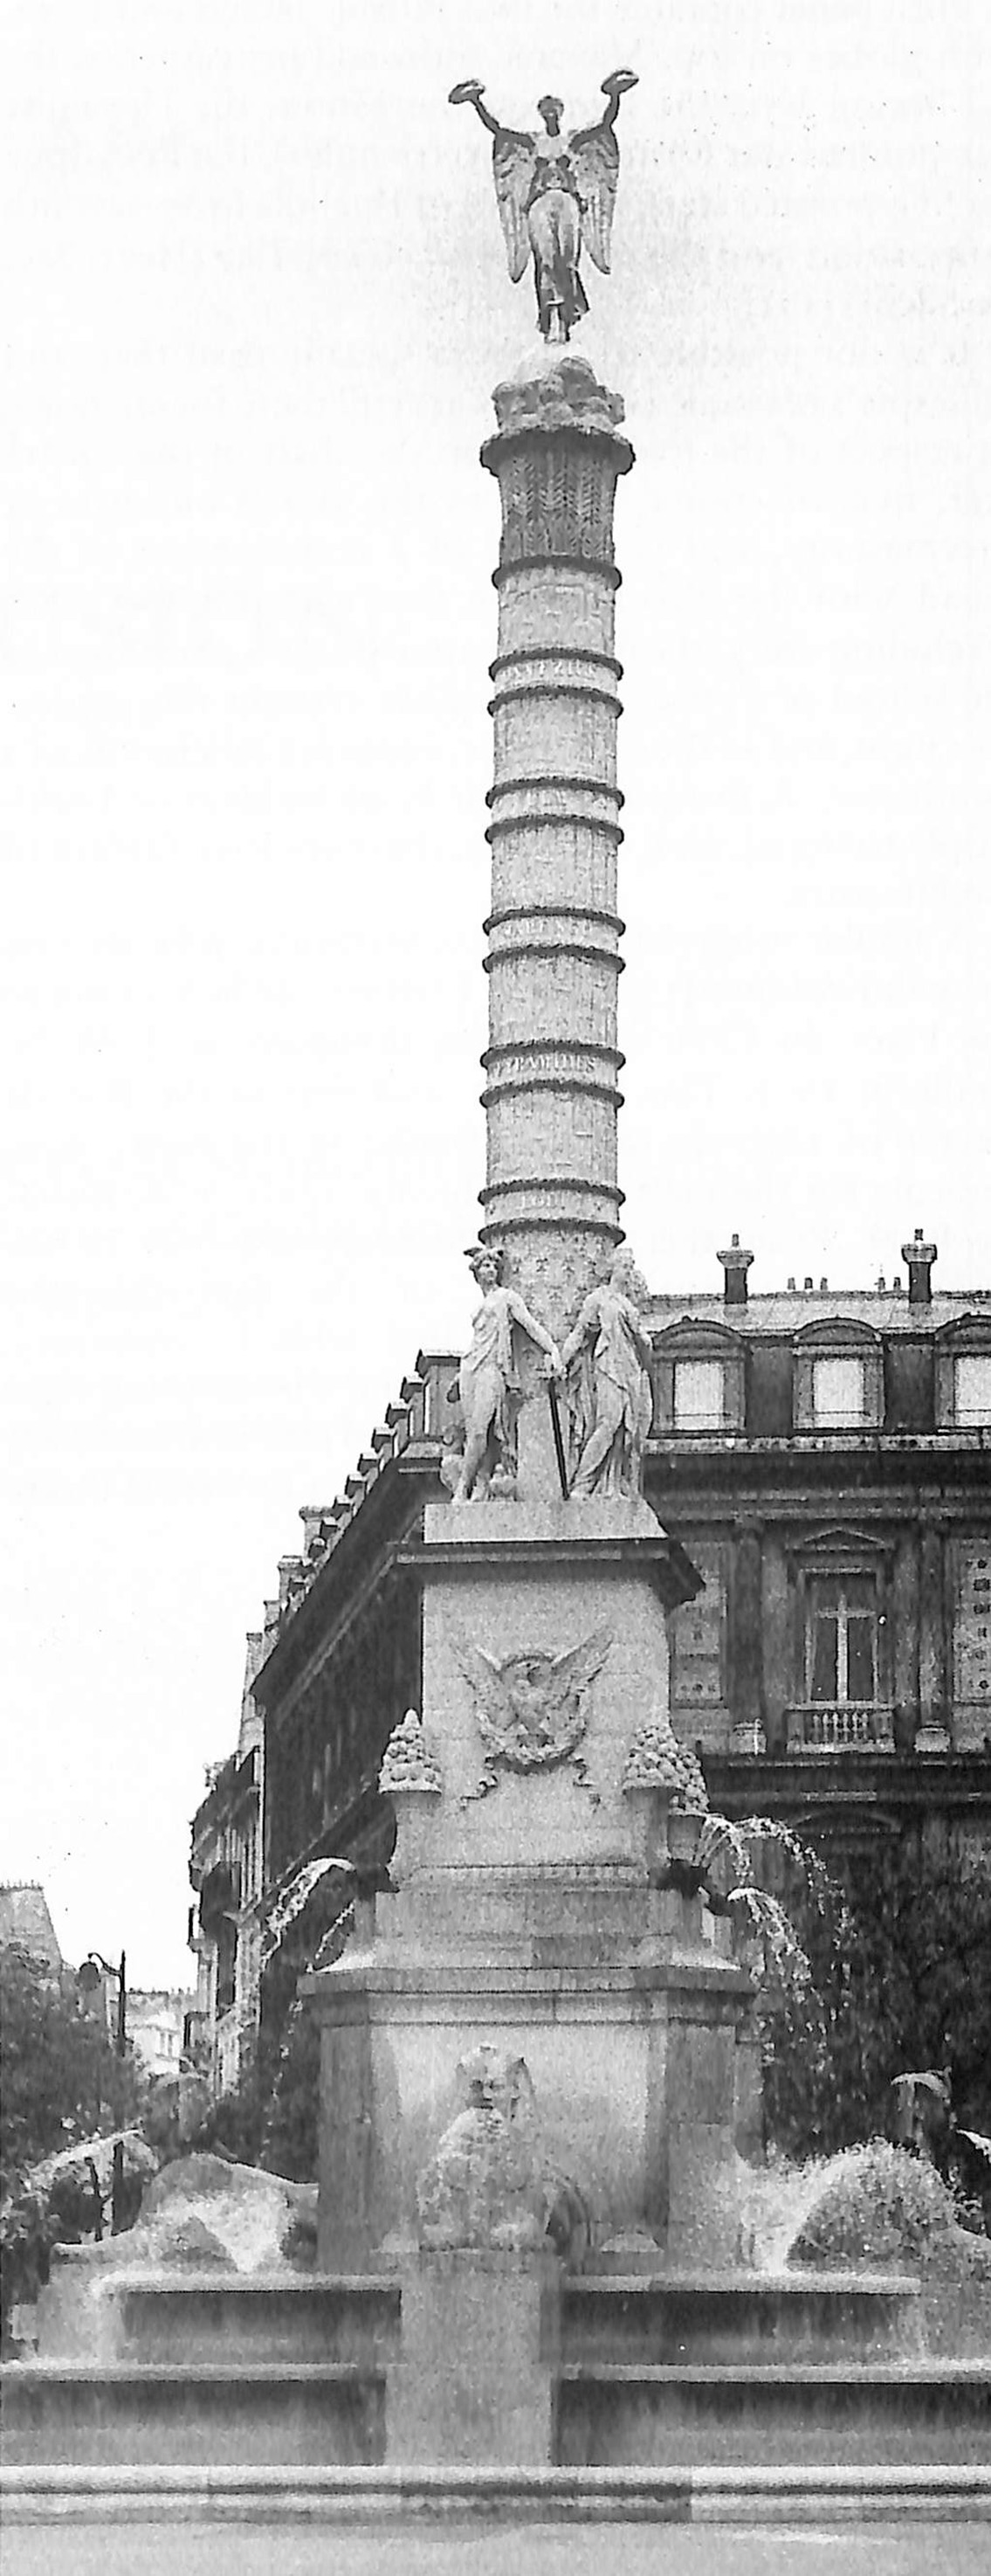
[10,2256,991,2473]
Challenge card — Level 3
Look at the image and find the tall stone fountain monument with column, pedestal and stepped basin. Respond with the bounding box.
[8,75,991,2491]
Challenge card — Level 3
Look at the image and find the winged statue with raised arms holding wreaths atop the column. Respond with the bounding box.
[451,73,636,340]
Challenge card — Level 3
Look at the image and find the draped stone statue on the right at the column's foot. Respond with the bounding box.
[561,1249,654,1496]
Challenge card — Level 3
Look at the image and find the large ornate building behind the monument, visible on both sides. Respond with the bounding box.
[193,1234,991,2066]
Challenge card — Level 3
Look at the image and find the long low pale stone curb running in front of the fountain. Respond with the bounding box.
[0,2465,991,2524]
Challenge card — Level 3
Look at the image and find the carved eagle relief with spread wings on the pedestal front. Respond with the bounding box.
[451,1628,613,1798]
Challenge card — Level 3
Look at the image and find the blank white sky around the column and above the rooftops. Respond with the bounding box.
[0,0,991,1984]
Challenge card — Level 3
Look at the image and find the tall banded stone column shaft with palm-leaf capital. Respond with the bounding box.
[478,353,633,1332]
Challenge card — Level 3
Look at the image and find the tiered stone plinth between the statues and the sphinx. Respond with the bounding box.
[304,1463,749,2267]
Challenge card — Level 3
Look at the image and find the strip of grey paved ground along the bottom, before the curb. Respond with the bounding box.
[3,2522,991,2576]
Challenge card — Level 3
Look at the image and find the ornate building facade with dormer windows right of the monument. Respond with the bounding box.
[646,1283,991,1849]
